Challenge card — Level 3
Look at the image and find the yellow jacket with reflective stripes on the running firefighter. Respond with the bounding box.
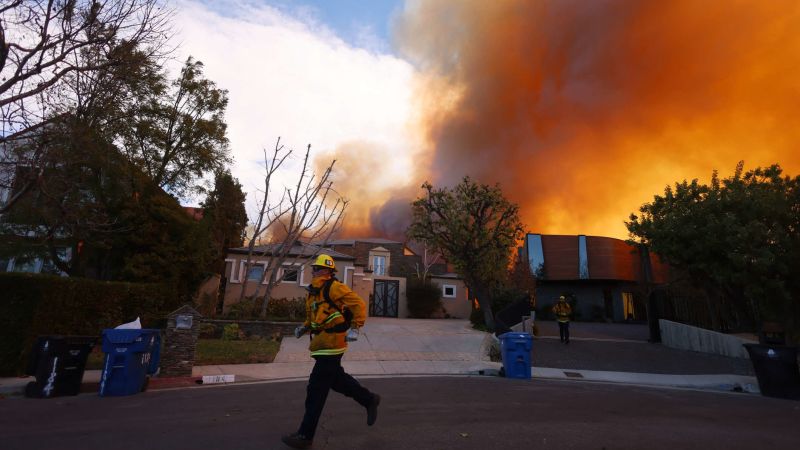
[303,277,367,356]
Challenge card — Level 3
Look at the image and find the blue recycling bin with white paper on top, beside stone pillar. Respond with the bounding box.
[100,328,161,396]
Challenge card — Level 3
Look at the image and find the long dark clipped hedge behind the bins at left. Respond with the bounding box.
[0,273,179,376]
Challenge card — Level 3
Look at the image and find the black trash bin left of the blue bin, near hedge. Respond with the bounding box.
[25,336,97,398]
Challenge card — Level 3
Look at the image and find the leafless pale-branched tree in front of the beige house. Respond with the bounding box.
[239,138,348,317]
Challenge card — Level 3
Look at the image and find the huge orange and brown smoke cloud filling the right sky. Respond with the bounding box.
[330,0,800,243]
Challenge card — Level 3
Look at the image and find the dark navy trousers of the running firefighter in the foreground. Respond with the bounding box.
[298,355,372,439]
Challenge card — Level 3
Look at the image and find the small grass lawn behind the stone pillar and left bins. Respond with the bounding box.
[86,339,281,370]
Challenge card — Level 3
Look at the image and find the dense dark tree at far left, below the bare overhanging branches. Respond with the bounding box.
[0,115,135,279]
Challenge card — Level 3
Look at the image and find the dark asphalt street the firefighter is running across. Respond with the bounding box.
[0,376,800,450]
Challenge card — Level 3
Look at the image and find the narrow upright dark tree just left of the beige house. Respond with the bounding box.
[202,170,247,273]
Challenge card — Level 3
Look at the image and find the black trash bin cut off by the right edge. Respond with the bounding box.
[744,344,800,400]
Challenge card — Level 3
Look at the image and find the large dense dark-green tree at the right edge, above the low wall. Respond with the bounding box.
[626,162,800,338]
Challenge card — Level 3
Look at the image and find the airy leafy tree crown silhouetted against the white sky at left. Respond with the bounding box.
[120,57,230,197]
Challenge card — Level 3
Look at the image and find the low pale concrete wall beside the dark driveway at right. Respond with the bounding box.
[658,319,757,359]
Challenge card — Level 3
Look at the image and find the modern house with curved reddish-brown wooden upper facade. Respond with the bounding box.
[519,233,669,321]
